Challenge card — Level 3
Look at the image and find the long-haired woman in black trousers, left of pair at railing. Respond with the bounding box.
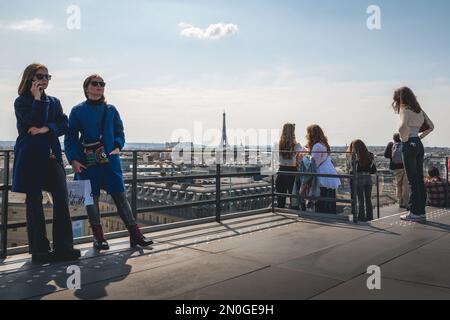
[275,123,305,208]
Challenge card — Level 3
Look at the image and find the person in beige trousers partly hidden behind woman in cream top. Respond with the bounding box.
[384,133,409,209]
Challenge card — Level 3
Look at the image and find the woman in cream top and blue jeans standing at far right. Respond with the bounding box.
[392,87,434,221]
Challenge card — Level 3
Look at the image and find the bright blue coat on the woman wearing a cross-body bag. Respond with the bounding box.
[64,101,125,195]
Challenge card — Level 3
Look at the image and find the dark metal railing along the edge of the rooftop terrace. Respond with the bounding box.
[0,149,449,258]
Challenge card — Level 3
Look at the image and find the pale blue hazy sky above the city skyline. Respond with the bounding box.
[0,0,450,147]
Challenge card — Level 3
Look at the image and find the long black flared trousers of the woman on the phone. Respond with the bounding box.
[26,159,73,254]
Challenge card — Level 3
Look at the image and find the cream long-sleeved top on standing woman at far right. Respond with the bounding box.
[398,107,434,142]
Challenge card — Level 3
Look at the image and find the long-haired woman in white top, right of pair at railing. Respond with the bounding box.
[306,124,341,213]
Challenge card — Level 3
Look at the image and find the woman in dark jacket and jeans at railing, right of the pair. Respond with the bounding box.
[347,140,377,221]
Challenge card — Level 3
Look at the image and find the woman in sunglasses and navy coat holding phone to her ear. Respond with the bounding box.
[12,64,80,262]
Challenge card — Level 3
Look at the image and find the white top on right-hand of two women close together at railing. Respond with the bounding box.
[311,143,341,189]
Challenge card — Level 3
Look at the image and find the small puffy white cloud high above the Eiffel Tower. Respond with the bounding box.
[178,22,239,40]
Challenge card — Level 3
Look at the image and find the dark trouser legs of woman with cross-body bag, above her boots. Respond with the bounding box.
[86,192,136,228]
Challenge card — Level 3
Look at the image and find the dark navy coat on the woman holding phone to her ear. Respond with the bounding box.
[12,95,67,193]
